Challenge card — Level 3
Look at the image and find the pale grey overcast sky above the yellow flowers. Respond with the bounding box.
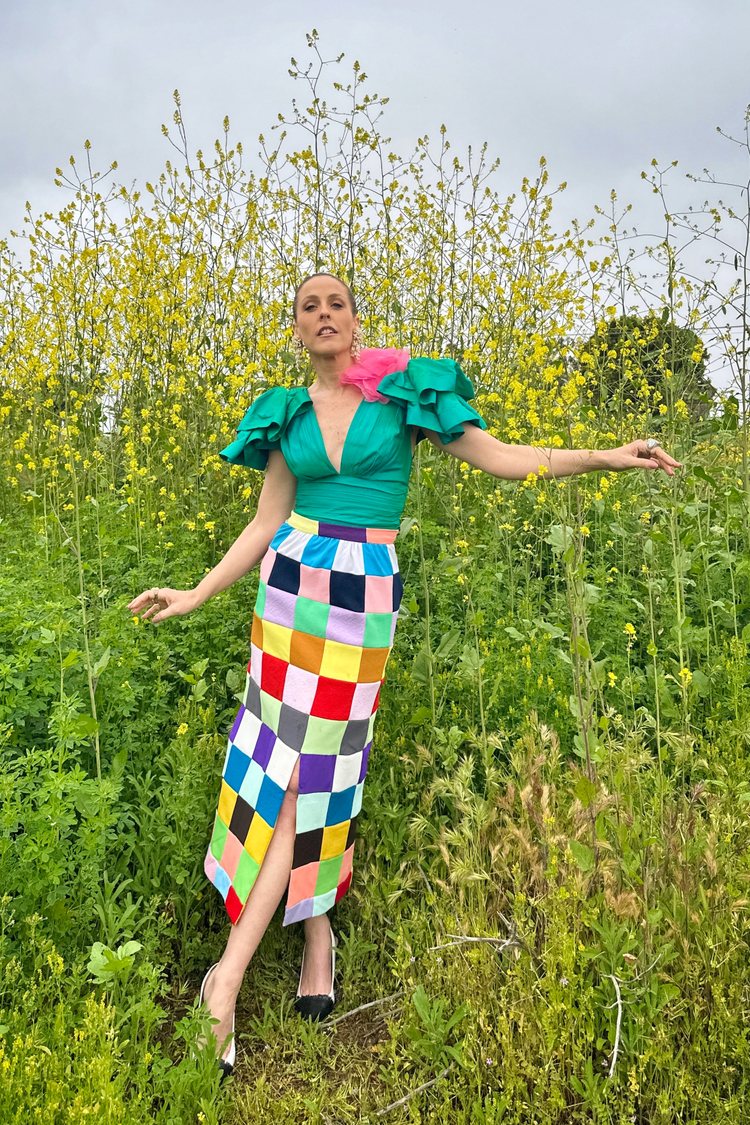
[0,0,750,248]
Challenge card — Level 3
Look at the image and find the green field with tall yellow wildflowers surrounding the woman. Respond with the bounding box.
[0,39,750,1125]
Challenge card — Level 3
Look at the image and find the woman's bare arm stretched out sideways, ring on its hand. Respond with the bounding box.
[424,423,681,480]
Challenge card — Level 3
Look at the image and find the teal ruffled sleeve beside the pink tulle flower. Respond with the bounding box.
[378,358,487,444]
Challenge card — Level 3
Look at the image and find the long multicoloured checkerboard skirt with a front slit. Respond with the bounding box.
[204,512,404,926]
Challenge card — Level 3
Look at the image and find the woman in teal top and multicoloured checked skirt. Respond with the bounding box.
[128,273,679,1073]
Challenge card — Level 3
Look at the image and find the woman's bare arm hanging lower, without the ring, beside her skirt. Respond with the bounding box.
[128,450,297,622]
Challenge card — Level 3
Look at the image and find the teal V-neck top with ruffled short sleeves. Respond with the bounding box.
[219,359,487,528]
